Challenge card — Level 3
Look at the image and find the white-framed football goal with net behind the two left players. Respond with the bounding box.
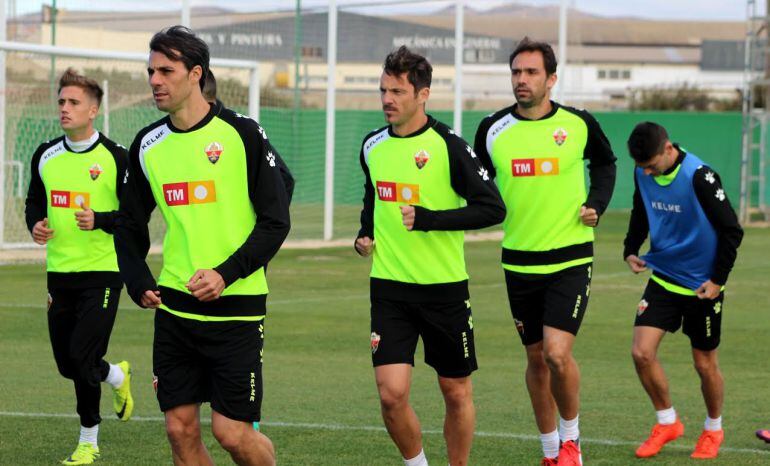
[0,41,260,249]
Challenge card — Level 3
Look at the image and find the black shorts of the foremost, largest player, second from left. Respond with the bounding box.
[152,309,264,422]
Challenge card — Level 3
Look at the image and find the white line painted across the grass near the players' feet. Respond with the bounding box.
[0,411,770,456]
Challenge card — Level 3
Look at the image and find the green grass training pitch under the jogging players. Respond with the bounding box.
[0,214,770,465]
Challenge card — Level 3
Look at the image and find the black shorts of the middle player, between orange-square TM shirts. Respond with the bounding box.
[371,297,478,378]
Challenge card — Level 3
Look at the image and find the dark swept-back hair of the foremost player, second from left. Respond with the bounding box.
[150,25,209,90]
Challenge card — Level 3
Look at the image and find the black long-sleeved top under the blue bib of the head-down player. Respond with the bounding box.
[623,146,743,285]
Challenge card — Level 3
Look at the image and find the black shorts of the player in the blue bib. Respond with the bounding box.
[634,280,725,351]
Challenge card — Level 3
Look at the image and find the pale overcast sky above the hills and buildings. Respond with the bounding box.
[15,0,752,21]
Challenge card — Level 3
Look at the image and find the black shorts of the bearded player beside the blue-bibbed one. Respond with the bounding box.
[505,264,592,346]
